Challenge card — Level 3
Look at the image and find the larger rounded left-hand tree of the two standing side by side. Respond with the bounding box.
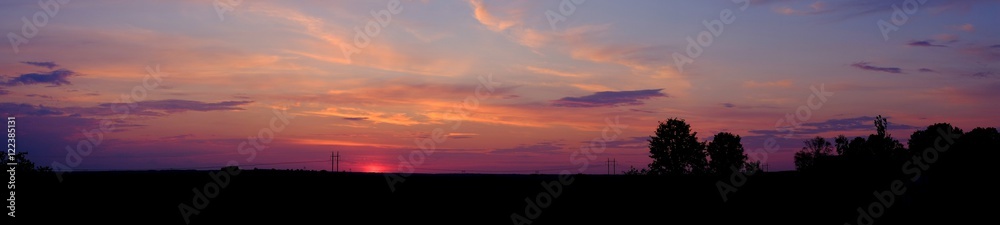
[649,118,707,175]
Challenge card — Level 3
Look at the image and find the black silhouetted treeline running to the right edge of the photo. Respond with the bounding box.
[795,116,1000,174]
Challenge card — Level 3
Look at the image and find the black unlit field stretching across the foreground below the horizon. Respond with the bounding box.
[5,164,998,224]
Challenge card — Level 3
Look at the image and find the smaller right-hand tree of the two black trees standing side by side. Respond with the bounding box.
[708,132,747,174]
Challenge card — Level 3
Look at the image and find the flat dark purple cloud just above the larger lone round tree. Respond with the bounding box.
[552,89,667,107]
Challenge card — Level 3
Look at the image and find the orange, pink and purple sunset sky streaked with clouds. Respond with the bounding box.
[0,0,1000,174]
